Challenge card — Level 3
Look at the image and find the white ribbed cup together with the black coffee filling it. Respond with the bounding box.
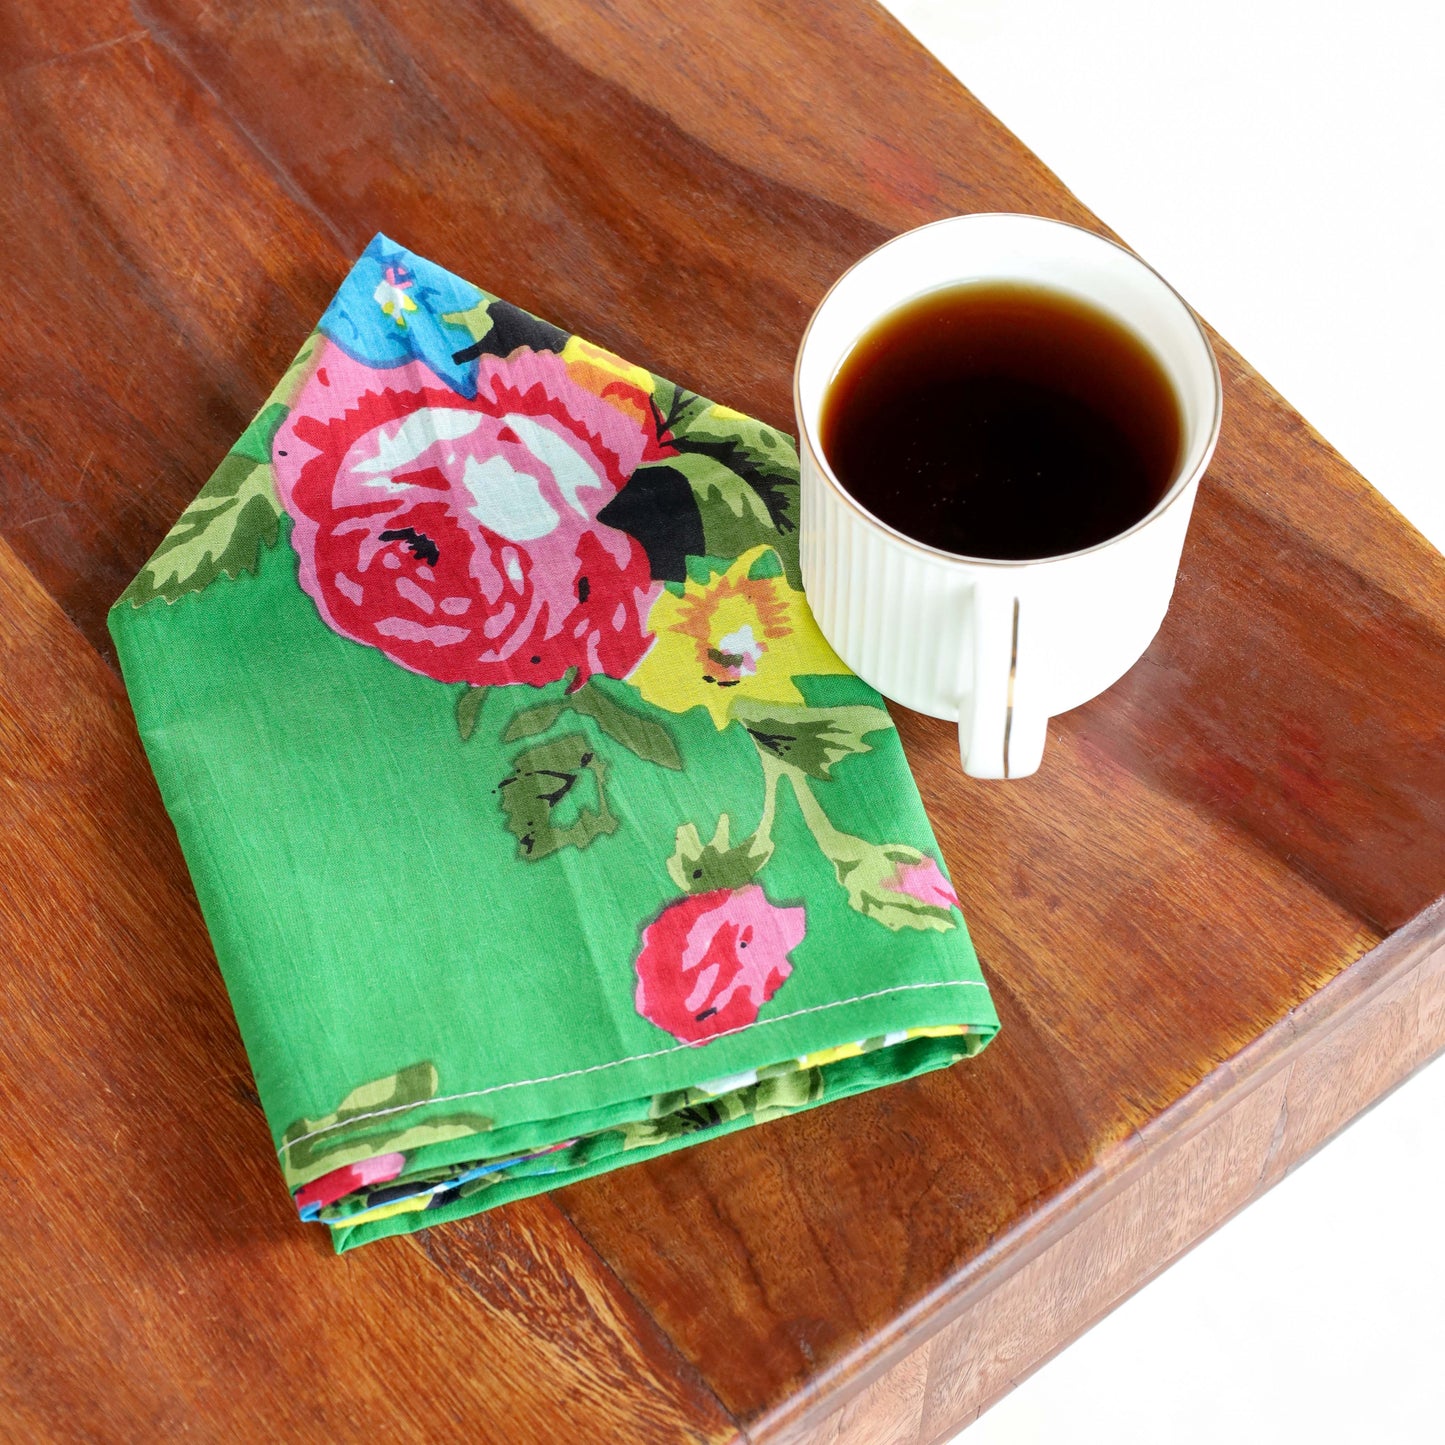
[793,214,1221,777]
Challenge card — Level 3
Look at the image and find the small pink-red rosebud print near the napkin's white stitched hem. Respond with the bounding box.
[637,883,805,1043]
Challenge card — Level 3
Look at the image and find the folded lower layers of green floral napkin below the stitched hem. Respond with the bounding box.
[329,1026,996,1254]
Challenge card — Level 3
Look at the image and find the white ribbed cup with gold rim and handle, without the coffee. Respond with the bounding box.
[793,214,1221,777]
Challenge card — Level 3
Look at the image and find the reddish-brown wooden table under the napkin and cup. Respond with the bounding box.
[0,0,1445,1445]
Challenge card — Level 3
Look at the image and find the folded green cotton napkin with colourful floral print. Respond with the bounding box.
[110,236,998,1250]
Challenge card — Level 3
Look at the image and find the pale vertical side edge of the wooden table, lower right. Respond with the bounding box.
[791,919,1445,1445]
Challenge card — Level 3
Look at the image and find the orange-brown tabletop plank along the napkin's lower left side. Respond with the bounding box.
[0,543,734,1445]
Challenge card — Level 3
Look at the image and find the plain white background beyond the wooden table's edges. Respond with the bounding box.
[867,0,1445,1445]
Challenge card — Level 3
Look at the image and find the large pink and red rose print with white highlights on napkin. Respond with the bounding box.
[272,341,660,686]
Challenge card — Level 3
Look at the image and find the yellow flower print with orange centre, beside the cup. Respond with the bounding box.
[627,546,848,728]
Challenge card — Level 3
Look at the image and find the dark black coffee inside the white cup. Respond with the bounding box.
[819,282,1183,561]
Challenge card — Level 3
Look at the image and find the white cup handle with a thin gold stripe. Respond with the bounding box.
[958,587,1049,777]
